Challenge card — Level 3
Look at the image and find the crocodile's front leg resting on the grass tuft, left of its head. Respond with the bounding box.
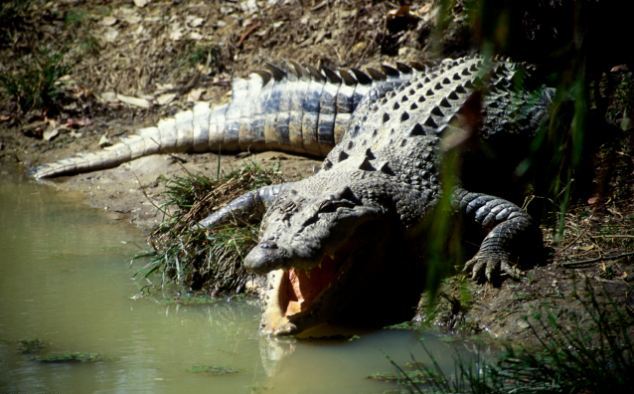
[198,182,292,228]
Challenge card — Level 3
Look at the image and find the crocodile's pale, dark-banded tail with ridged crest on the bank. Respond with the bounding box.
[31,62,424,179]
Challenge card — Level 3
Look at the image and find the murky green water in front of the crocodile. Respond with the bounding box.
[0,175,464,393]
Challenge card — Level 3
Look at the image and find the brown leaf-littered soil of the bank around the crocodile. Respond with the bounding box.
[0,0,634,340]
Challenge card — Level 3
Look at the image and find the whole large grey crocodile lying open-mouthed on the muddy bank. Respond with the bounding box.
[34,55,553,336]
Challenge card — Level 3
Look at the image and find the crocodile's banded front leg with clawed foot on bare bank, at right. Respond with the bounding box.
[452,188,536,281]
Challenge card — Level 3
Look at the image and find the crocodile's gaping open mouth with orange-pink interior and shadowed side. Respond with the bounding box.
[262,216,389,338]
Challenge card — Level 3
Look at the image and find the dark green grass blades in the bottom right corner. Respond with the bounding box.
[388,282,634,394]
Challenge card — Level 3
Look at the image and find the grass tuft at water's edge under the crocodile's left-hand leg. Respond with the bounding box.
[138,164,280,294]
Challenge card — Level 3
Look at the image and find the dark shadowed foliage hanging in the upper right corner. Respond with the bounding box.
[431,0,634,240]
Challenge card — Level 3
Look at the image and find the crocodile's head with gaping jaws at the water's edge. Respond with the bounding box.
[245,172,422,336]
